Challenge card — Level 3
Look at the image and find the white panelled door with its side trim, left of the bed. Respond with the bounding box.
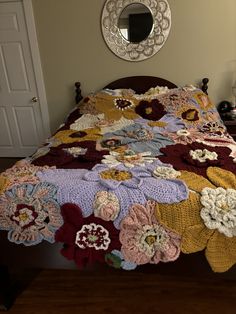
[0,0,49,157]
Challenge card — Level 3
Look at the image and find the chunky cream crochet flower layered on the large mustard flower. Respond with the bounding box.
[200,187,236,237]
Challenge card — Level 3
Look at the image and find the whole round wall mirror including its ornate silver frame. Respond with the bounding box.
[101,0,171,61]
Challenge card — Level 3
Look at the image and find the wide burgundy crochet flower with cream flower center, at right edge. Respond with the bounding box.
[158,143,236,176]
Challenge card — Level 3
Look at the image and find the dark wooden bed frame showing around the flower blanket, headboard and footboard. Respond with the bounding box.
[0,76,236,306]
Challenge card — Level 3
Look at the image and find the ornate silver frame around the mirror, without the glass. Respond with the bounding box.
[101,0,171,61]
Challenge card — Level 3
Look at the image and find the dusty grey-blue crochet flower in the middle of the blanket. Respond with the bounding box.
[104,123,173,156]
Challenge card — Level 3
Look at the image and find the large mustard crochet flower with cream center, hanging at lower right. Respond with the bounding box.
[156,167,236,272]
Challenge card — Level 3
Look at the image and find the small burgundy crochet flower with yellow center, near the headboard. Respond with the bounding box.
[135,99,167,121]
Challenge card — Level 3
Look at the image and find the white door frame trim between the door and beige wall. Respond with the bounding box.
[0,0,51,138]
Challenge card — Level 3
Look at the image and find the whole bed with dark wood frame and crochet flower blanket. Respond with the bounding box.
[0,76,236,273]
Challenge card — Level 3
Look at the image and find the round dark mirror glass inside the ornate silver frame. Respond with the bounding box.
[118,3,153,43]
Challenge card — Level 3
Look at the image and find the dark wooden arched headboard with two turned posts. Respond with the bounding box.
[75,76,209,104]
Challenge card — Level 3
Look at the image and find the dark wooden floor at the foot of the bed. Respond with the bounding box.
[8,267,236,314]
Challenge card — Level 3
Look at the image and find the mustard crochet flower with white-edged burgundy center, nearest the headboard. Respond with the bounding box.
[94,93,139,120]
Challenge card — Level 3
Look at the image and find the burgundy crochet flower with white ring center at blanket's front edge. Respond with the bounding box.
[55,203,120,268]
